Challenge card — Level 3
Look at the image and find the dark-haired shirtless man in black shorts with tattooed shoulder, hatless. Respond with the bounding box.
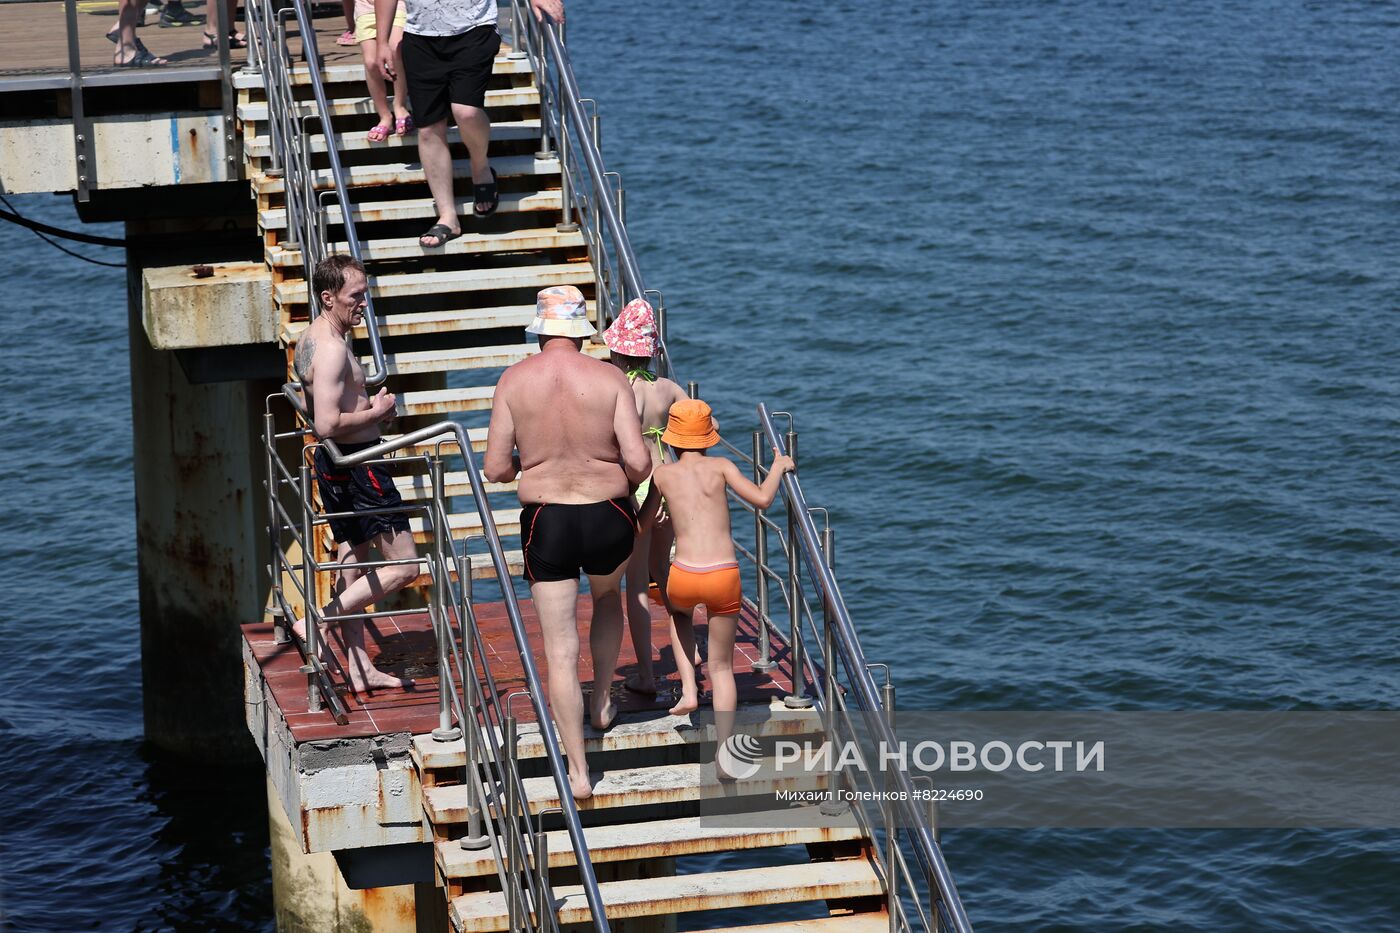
[293,256,419,693]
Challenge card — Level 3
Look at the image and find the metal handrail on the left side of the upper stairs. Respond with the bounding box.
[246,0,389,388]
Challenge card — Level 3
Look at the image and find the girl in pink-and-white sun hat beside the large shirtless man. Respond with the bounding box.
[603,298,689,695]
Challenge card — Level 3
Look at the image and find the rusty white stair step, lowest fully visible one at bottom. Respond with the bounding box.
[452,859,882,933]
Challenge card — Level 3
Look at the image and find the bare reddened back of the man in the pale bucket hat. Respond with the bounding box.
[496,343,640,504]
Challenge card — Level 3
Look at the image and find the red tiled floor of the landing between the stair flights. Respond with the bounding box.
[242,590,811,742]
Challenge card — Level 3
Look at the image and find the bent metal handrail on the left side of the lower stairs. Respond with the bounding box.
[281,382,610,933]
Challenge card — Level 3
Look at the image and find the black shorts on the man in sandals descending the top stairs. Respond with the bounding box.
[399,24,501,126]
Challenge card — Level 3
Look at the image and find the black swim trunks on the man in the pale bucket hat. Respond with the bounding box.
[521,496,637,583]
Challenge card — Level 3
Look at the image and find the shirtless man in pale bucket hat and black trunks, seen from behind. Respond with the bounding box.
[482,286,651,800]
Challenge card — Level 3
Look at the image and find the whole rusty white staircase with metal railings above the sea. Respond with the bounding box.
[235,0,970,933]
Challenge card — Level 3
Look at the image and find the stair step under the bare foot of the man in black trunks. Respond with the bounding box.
[423,762,827,827]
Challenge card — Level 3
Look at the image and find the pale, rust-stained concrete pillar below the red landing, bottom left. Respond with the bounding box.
[267,780,449,933]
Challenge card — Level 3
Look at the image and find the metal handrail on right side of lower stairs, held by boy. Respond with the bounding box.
[759,403,972,933]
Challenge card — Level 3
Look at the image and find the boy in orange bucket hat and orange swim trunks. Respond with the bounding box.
[643,399,795,779]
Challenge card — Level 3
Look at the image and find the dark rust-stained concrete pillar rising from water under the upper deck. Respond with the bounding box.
[127,251,276,763]
